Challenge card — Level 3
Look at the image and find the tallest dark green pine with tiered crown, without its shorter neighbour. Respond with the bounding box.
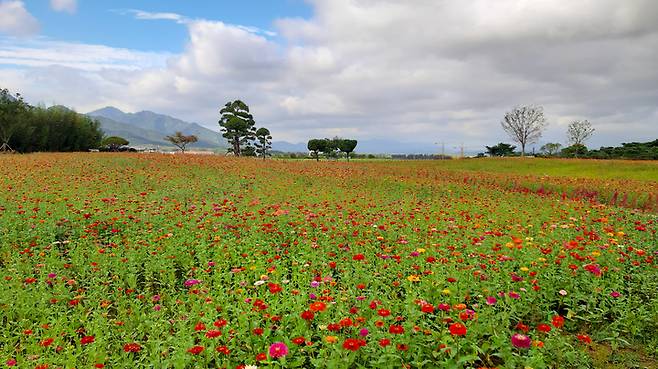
[219,100,256,156]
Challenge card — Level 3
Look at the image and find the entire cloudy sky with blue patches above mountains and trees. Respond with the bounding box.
[0,0,658,151]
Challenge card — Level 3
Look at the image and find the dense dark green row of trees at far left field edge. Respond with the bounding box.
[0,89,103,153]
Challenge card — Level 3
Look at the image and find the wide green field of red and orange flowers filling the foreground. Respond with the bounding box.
[0,154,658,369]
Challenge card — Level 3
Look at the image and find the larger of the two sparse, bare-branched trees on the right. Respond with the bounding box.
[500,106,548,156]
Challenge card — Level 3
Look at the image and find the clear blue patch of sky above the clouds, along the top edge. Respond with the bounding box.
[25,0,311,53]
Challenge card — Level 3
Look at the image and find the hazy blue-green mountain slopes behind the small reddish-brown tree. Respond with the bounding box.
[87,106,227,149]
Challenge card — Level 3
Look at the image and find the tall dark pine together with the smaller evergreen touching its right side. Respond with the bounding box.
[219,100,272,159]
